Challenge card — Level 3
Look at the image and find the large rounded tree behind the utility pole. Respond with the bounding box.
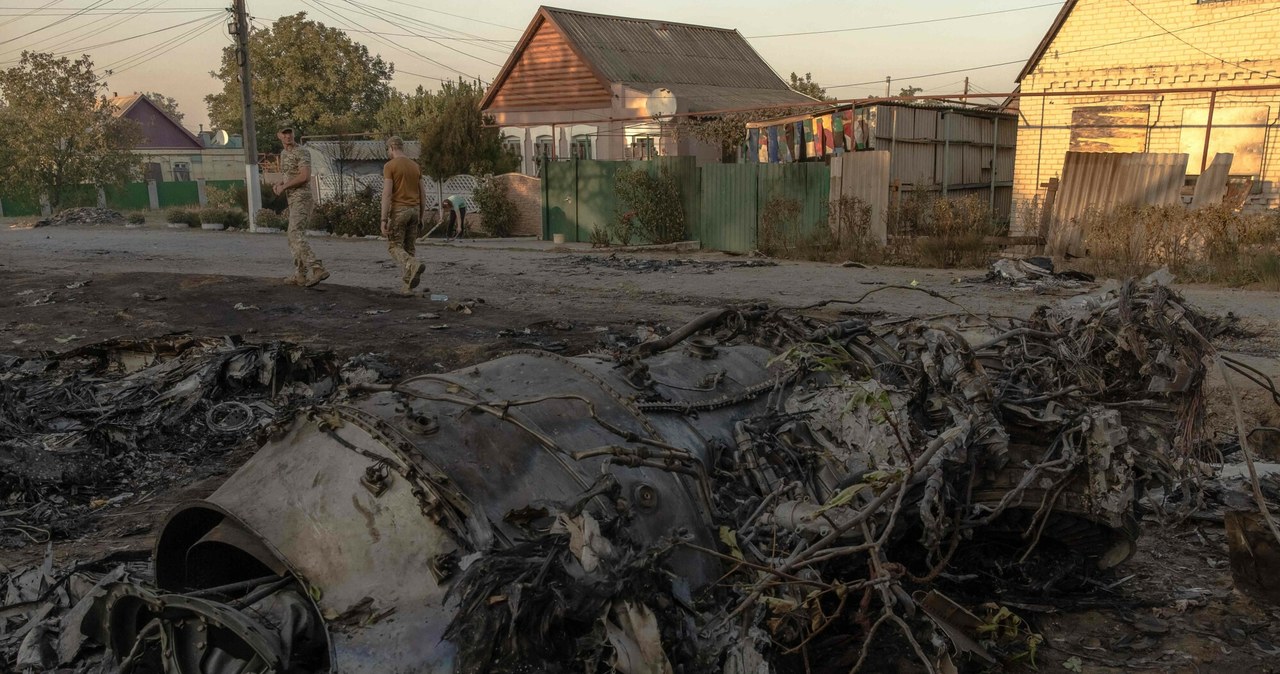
[205,12,393,151]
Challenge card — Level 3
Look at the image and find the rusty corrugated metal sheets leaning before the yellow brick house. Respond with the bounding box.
[1047,152,1188,256]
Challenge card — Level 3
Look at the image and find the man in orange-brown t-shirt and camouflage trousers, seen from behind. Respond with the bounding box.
[381,136,426,294]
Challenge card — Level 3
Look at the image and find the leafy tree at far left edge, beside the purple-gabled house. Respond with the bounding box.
[0,51,142,208]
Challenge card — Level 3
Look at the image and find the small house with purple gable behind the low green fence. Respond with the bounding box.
[108,93,244,183]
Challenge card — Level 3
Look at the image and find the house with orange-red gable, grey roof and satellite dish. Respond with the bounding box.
[481,6,814,175]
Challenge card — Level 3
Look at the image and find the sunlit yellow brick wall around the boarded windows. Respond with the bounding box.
[1014,0,1280,233]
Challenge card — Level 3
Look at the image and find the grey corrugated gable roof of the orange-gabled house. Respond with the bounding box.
[481,6,814,111]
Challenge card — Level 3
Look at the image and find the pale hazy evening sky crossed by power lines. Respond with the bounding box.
[0,0,1061,132]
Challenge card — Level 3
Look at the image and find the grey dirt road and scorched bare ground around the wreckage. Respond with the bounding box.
[0,226,1280,671]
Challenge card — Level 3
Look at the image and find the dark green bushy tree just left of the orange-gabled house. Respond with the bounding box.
[417,79,518,180]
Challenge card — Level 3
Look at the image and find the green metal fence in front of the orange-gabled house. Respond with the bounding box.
[543,157,831,252]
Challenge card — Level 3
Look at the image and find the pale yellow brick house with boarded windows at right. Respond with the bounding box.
[1014,0,1280,234]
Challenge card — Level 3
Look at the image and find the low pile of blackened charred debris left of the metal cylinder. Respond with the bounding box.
[0,338,337,547]
